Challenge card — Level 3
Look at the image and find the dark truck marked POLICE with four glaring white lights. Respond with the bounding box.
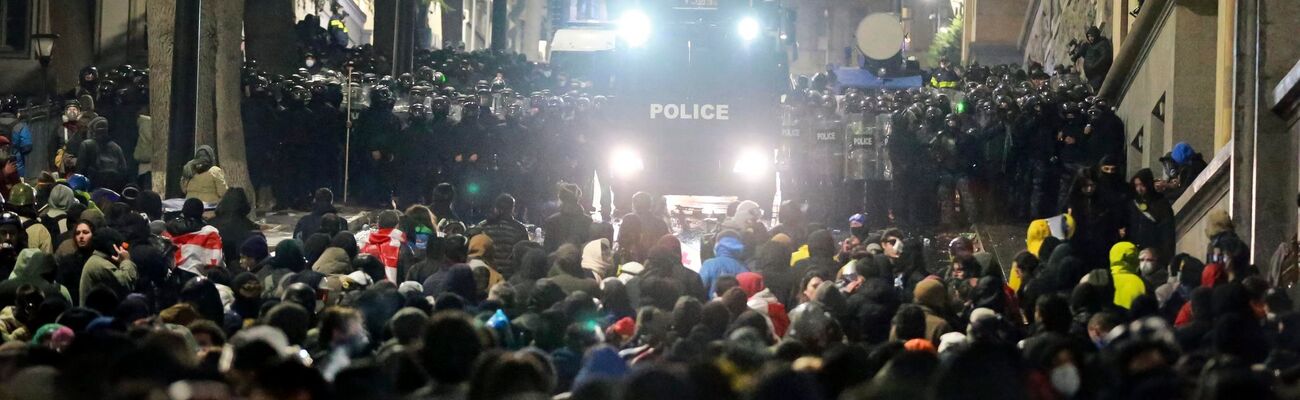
[549,0,789,214]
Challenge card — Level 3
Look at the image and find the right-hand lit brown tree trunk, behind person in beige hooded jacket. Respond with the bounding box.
[208,0,250,210]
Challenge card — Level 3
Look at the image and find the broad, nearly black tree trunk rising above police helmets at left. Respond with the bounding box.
[243,0,300,74]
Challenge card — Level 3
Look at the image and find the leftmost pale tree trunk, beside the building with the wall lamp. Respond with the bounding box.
[146,0,177,194]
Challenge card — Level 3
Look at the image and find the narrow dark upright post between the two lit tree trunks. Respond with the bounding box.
[194,0,218,148]
